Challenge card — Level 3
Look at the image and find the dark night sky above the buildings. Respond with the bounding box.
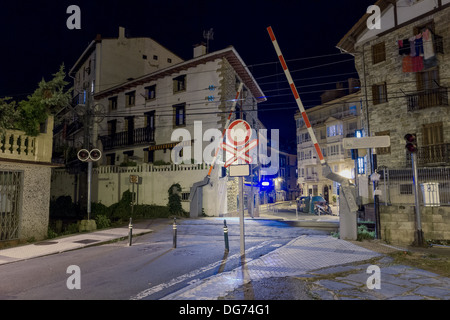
[0,0,375,153]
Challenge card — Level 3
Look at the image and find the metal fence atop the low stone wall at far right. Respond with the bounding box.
[378,167,450,206]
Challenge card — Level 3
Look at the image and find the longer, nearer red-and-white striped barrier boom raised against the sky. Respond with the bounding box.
[267,27,326,165]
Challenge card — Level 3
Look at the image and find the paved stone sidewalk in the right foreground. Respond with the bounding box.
[163,235,450,300]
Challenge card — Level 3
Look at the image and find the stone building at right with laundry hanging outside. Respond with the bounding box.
[337,0,450,243]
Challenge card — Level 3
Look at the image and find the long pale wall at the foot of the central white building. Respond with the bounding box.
[51,164,235,216]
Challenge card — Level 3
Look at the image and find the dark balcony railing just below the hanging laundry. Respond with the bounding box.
[406,87,448,111]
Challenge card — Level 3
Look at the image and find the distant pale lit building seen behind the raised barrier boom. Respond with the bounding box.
[295,90,365,202]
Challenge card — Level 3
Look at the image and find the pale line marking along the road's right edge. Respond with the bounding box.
[130,240,274,300]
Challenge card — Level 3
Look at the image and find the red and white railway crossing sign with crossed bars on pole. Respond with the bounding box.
[220,119,258,168]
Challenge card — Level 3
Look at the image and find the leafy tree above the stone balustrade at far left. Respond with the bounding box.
[0,65,72,136]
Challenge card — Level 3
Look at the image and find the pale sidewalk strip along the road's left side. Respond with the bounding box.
[0,222,152,265]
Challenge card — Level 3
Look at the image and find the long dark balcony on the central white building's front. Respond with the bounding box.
[100,127,155,150]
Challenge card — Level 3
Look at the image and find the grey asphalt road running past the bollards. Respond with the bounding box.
[0,218,323,300]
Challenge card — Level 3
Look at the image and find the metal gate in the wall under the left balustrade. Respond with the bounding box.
[0,171,22,241]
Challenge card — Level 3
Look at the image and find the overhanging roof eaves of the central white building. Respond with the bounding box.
[94,46,267,102]
